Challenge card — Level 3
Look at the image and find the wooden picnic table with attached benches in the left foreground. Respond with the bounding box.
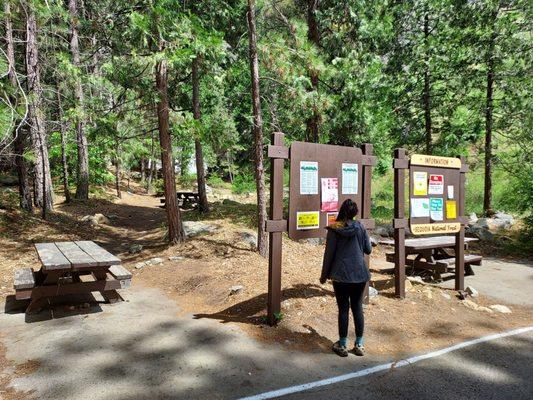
[14,240,131,312]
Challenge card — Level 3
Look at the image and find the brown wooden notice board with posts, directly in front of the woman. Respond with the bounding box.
[264,132,377,325]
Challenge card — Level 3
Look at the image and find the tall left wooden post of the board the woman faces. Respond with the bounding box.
[265,132,288,325]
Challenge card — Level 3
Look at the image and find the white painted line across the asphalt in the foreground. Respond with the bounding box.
[239,326,533,400]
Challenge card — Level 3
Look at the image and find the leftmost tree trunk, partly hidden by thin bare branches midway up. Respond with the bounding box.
[4,0,33,212]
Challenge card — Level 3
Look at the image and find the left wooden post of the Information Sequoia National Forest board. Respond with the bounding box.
[393,149,409,298]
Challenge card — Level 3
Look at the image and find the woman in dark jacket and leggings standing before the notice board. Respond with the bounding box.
[320,199,372,357]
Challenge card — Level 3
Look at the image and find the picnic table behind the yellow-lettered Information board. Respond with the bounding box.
[379,236,482,275]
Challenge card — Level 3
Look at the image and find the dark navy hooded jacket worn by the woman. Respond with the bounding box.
[321,221,372,283]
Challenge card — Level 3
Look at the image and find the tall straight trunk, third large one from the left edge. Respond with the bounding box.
[68,0,89,200]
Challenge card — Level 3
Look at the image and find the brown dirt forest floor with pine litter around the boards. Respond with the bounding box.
[0,181,533,396]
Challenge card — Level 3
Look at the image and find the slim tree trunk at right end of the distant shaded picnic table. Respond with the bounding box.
[192,56,209,213]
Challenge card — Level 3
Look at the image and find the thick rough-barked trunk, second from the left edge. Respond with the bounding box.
[25,4,53,218]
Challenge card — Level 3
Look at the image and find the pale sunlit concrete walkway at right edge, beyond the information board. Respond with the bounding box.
[442,258,533,307]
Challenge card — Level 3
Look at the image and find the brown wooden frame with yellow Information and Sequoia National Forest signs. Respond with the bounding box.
[393,149,468,298]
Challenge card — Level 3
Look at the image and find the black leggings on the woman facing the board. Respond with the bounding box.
[333,281,366,338]
